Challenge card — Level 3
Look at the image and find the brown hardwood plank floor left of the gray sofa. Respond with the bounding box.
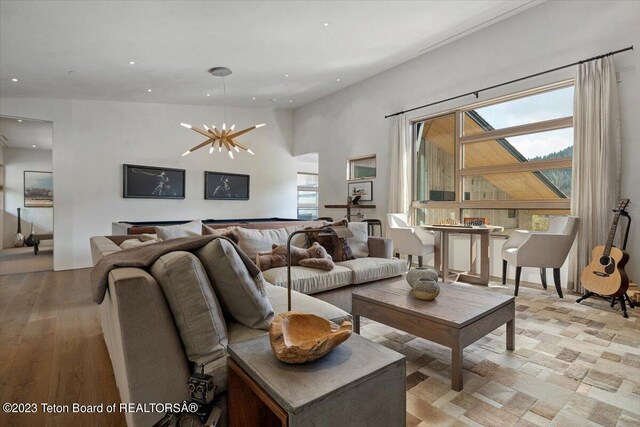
[0,269,125,426]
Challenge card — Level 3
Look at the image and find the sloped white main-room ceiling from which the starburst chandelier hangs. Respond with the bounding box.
[0,0,540,108]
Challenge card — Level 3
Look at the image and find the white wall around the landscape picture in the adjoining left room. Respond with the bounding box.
[2,148,53,248]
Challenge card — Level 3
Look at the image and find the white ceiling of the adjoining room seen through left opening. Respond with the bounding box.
[0,117,53,150]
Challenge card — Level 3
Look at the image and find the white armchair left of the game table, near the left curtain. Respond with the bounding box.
[387,213,435,267]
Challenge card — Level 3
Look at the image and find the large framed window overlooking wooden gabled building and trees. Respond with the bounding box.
[413,81,573,232]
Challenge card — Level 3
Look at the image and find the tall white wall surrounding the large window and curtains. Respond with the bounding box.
[294,1,640,281]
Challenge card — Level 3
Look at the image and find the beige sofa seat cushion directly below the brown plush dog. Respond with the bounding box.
[263,265,353,294]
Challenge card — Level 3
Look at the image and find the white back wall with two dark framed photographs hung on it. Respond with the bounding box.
[0,98,296,270]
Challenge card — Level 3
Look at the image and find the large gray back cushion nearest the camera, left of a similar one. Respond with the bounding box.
[150,251,228,365]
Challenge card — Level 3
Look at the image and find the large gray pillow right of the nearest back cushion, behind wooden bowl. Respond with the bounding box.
[195,239,273,330]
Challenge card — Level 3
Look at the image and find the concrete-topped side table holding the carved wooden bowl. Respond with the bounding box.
[228,334,406,427]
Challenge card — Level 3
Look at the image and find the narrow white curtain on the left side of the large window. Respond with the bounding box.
[389,114,411,214]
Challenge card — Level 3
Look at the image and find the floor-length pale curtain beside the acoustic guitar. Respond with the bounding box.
[567,56,621,292]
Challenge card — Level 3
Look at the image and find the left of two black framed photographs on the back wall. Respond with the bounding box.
[122,165,185,199]
